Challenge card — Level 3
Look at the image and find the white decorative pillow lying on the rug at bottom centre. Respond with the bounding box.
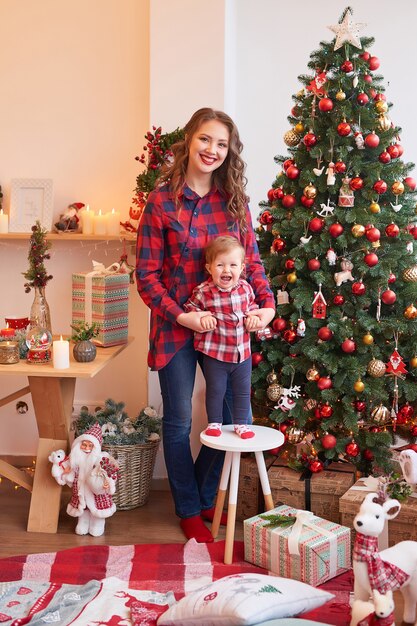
[157,573,334,626]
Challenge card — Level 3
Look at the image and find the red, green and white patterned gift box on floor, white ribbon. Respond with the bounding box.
[243,505,351,586]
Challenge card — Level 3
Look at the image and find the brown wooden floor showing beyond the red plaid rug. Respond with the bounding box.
[0,479,403,625]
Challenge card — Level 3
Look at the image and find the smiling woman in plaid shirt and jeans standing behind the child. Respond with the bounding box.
[136,108,275,542]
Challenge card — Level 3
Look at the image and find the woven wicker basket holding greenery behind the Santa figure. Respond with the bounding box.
[102,441,159,511]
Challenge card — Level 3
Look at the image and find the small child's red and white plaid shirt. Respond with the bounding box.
[184,278,258,363]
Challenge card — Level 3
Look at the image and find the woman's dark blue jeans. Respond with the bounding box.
[158,339,232,518]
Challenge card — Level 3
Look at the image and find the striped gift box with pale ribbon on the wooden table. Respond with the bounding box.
[72,272,130,346]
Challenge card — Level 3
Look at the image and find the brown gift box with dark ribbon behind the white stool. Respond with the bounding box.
[236,457,355,524]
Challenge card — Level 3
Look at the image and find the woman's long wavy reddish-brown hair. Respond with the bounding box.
[157,107,249,232]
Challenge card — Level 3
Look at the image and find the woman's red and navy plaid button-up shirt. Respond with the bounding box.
[136,185,275,370]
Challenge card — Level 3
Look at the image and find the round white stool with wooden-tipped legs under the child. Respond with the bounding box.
[200,425,284,565]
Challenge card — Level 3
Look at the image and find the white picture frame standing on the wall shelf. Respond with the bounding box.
[9,178,53,233]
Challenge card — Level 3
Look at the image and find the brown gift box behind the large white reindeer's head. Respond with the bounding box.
[339,479,417,549]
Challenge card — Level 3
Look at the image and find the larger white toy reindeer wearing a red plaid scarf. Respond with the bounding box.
[353,493,417,624]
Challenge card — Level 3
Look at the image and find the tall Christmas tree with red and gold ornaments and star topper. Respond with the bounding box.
[252,7,417,473]
